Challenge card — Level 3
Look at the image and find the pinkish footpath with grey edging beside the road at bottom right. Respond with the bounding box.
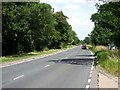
[90,66,120,90]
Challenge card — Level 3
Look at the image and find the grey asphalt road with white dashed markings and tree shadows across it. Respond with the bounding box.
[2,47,97,88]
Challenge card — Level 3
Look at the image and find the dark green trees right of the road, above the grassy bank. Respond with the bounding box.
[85,2,120,48]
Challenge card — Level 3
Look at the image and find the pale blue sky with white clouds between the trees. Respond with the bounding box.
[40,0,97,40]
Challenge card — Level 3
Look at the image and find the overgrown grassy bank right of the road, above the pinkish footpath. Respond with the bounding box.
[88,45,120,76]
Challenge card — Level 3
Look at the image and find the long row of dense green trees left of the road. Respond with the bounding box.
[2,2,79,55]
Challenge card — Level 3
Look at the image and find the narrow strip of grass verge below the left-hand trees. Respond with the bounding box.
[0,45,75,63]
